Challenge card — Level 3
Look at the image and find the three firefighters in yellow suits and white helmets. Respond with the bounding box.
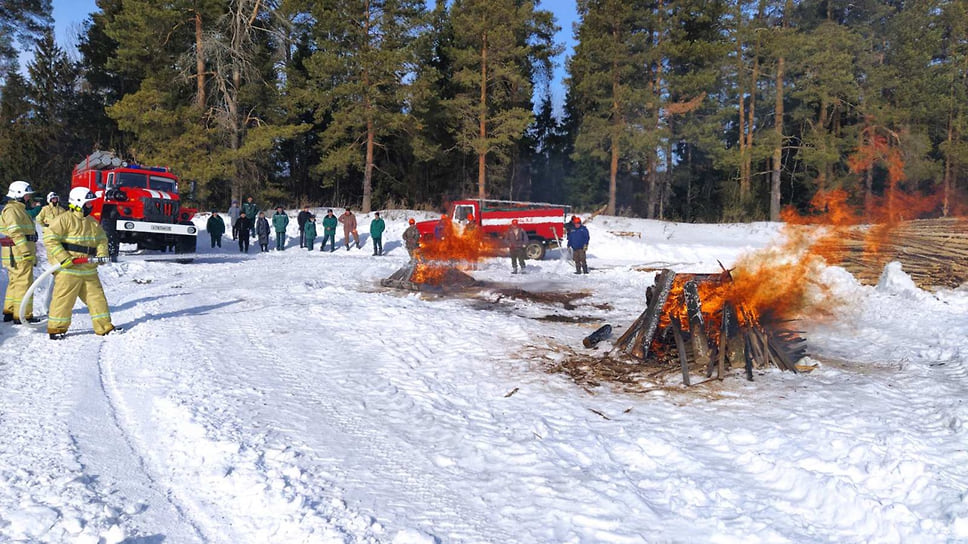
[0,181,117,340]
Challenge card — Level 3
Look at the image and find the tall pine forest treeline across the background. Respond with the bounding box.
[0,0,968,221]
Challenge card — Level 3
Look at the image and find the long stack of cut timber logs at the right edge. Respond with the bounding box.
[819,218,968,288]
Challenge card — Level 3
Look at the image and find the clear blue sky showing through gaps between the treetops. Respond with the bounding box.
[52,0,578,107]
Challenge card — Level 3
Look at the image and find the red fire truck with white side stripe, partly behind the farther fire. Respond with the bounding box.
[417,200,571,260]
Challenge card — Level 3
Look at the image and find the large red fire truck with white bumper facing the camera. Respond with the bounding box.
[71,151,198,258]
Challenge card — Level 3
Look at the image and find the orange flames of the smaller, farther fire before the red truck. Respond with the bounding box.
[412,220,500,285]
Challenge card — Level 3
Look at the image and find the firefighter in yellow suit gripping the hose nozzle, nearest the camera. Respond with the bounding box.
[44,187,114,340]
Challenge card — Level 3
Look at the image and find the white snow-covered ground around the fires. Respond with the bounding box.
[0,211,968,544]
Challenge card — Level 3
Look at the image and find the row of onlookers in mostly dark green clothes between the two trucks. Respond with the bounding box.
[214,200,386,255]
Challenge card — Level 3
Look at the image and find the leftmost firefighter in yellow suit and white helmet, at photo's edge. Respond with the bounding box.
[0,181,37,324]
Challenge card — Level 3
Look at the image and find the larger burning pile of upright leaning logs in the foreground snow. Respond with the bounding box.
[615,270,806,385]
